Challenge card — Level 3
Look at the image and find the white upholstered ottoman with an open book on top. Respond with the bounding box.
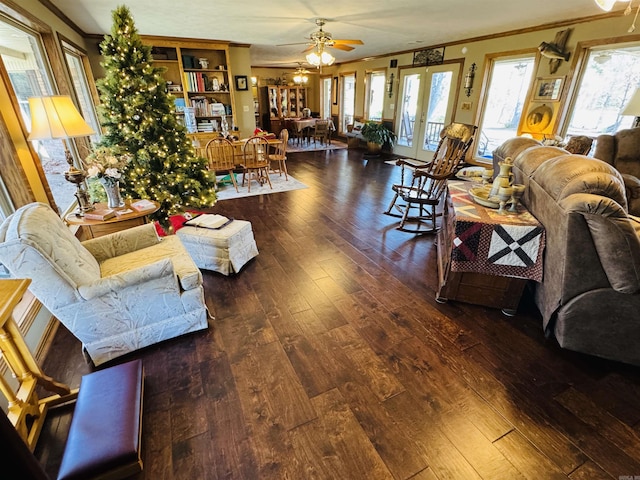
[176,220,258,275]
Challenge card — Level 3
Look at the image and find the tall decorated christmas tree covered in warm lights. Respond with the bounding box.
[97,6,216,228]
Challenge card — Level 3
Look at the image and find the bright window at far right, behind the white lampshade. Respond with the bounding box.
[566,45,640,137]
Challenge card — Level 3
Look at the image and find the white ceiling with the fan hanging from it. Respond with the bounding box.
[51,0,608,67]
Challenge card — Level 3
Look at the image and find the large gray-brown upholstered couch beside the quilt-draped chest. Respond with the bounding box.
[499,141,640,365]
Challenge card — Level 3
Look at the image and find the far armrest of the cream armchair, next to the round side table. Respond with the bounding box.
[82,223,160,263]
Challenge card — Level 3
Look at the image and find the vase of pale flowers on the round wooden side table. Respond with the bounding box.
[85,146,131,208]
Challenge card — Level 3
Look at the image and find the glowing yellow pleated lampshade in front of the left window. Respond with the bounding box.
[28,95,96,140]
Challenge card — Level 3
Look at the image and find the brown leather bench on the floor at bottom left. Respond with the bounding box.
[58,360,144,480]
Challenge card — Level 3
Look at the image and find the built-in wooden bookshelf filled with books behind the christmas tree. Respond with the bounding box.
[143,36,235,135]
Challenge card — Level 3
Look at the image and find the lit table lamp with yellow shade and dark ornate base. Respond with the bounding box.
[28,95,96,216]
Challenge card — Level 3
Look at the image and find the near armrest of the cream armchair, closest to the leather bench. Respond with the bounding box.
[78,258,178,300]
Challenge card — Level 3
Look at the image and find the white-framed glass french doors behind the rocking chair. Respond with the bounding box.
[393,64,460,160]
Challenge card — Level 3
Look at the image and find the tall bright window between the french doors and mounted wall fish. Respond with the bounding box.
[476,53,535,158]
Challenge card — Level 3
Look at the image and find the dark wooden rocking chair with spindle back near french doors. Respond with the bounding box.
[384,123,477,233]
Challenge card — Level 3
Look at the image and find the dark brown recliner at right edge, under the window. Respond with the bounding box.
[593,128,640,216]
